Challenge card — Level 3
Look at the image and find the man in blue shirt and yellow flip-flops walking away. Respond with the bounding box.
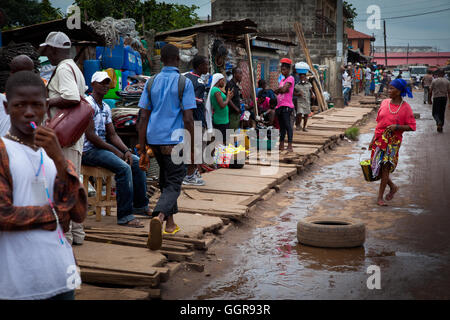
[139,44,197,250]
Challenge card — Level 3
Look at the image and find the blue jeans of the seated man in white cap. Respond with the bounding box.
[81,148,148,224]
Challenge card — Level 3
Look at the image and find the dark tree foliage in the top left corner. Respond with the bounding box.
[0,0,62,29]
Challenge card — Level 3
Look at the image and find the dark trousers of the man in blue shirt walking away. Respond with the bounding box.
[150,145,186,219]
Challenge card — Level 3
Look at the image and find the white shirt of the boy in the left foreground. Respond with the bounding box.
[0,138,79,300]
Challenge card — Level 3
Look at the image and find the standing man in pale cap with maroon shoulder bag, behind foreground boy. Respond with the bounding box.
[40,31,87,244]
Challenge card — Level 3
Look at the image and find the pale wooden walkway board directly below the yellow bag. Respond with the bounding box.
[213,165,297,184]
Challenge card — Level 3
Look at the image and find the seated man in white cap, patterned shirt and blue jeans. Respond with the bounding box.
[82,71,151,228]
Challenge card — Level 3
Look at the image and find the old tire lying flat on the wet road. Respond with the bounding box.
[297,217,366,248]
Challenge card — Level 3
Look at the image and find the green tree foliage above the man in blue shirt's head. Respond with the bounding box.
[75,0,200,31]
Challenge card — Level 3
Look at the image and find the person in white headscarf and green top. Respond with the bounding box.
[206,73,233,144]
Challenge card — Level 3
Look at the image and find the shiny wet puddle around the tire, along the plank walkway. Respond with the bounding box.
[192,102,430,299]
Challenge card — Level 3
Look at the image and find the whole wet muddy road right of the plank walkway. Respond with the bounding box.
[162,92,450,299]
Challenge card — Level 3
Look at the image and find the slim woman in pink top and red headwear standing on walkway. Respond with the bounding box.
[274,58,295,152]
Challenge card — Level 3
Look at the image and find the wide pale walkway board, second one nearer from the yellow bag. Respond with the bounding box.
[183,171,270,195]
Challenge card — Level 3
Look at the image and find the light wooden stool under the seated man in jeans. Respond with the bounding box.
[81,165,116,221]
